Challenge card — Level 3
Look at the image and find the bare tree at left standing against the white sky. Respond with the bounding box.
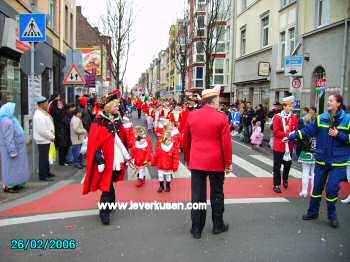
[102,0,135,92]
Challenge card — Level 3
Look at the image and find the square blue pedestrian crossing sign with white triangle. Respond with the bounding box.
[19,14,46,42]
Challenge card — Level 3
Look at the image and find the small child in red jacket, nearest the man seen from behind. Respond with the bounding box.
[152,131,180,193]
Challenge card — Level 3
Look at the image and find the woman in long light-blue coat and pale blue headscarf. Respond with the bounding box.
[0,103,29,193]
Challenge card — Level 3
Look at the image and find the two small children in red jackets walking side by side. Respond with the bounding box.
[123,115,180,193]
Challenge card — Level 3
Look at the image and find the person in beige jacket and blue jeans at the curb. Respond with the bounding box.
[70,110,87,169]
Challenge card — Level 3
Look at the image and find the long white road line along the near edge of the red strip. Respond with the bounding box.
[0,197,289,227]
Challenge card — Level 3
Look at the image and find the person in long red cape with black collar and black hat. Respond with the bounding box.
[83,94,131,225]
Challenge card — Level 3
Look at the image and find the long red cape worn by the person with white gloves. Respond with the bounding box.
[83,118,127,194]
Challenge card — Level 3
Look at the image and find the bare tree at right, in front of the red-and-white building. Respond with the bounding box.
[197,0,232,88]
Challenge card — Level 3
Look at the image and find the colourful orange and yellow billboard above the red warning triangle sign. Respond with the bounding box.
[80,48,102,76]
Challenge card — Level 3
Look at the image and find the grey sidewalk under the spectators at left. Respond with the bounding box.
[0,144,85,206]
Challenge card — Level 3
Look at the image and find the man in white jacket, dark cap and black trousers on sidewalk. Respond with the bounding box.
[33,96,55,181]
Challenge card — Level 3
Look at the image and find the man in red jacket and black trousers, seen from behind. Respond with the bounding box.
[183,87,232,239]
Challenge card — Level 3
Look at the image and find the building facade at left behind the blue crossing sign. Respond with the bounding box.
[0,0,76,131]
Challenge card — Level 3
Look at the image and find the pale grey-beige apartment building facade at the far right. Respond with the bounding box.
[233,0,350,109]
